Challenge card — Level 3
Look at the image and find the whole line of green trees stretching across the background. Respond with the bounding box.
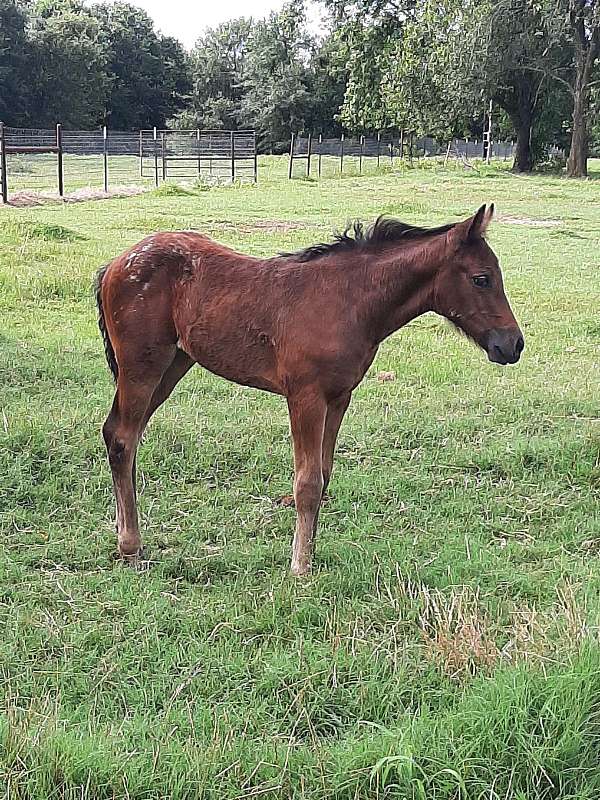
[0,0,600,175]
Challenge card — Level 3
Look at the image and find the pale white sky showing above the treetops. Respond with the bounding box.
[91,0,323,49]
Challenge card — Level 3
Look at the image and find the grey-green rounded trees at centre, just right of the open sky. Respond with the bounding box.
[178,3,346,151]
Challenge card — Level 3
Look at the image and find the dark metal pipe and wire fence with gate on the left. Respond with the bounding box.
[0,123,258,203]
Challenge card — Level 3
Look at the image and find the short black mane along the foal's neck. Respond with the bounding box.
[281,215,455,261]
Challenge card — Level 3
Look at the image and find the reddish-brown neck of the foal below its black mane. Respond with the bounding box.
[360,234,444,342]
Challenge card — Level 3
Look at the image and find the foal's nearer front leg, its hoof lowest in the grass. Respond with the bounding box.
[288,389,327,576]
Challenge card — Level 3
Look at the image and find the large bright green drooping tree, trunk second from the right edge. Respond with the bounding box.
[330,0,565,172]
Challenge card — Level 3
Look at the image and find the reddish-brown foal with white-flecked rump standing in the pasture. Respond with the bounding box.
[96,200,524,576]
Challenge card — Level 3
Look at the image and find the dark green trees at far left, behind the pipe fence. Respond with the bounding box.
[0,0,190,130]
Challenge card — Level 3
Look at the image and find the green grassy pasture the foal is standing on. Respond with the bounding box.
[0,159,600,800]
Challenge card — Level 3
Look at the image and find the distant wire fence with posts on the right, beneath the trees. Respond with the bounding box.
[288,131,515,178]
